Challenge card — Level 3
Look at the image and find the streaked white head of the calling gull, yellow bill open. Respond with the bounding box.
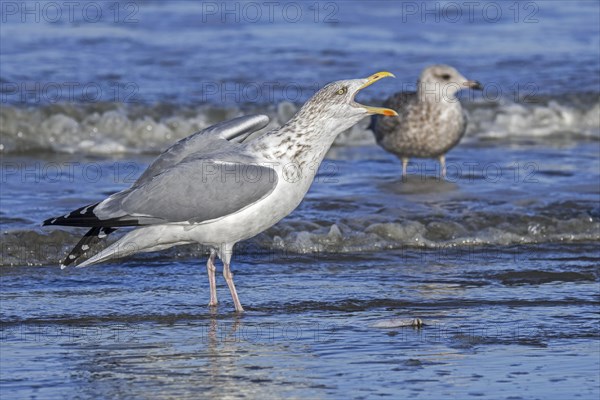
[299,71,398,131]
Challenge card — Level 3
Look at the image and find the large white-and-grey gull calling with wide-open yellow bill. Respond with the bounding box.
[44,71,398,313]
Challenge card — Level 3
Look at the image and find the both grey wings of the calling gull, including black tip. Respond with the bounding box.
[43,115,277,228]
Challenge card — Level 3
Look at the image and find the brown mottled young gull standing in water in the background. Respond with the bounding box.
[371,64,483,177]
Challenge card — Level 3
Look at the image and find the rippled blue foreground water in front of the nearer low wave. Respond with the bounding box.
[1,245,600,399]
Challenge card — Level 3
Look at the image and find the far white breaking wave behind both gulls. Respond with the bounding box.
[0,94,600,154]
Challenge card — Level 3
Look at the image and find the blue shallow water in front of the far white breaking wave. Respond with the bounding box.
[0,142,600,399]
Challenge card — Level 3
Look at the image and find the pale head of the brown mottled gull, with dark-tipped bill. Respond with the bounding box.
[419,64,483,96]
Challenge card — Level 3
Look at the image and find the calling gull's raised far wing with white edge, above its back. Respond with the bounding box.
[133,114,269,187]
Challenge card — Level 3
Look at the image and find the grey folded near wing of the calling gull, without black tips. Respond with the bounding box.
[93,159,278,225]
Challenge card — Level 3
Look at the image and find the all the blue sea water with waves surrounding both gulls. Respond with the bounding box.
[0,1,600,399]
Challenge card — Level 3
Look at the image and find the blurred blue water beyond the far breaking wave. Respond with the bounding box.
[0,1,600,105]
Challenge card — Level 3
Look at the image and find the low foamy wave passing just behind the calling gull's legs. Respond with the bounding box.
[0,204,600,265]
